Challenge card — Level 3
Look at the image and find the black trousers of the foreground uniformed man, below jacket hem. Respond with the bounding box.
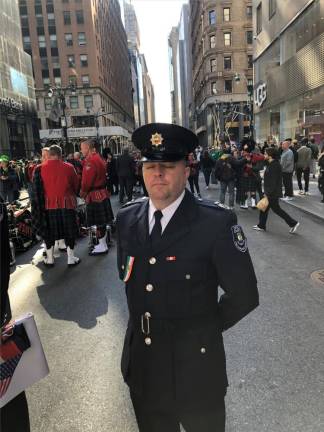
[131,394,226,432]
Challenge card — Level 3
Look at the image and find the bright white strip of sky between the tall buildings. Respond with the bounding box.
[131,0,188,122]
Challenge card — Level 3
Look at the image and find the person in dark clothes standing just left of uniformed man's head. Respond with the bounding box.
[116,148,135,204]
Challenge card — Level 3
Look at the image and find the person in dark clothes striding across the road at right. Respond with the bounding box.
[253,148,299,234]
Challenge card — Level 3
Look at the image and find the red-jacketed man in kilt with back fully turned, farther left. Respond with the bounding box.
[40,145,80,267]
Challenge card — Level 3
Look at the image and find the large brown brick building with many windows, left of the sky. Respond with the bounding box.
[19,0,134,150]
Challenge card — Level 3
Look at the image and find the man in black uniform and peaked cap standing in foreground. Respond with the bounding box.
[117,123,258,432]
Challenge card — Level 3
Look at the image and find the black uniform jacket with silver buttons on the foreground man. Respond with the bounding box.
[117,191,258,407]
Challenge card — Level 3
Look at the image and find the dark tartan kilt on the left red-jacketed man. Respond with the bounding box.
[45,209,78,240]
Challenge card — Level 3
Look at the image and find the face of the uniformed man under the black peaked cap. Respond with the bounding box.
[143,160,190,207]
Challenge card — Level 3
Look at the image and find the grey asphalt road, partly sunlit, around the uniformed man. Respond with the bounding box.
[9,189,324,432]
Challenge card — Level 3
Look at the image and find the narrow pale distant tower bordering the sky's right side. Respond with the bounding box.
[169,4,192,128]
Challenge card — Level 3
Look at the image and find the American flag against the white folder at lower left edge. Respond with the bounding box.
[0,324,30,397]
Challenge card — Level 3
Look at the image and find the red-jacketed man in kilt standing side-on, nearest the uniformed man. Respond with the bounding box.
[80,139,113,255]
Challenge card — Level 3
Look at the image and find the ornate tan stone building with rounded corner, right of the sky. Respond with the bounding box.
[190,0,253,146]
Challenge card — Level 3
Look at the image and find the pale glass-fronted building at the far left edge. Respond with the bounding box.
[0,0,39,158]
